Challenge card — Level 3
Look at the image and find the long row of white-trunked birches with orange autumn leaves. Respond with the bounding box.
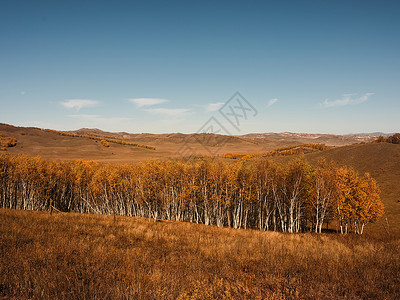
[0,154,383,234]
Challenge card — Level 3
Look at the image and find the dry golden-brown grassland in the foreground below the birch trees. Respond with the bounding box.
[0,209,400,299]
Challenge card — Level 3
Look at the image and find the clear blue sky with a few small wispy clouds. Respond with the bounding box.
[0,0,400,134]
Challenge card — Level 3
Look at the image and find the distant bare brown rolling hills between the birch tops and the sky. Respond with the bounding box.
[0,124,375,163]
